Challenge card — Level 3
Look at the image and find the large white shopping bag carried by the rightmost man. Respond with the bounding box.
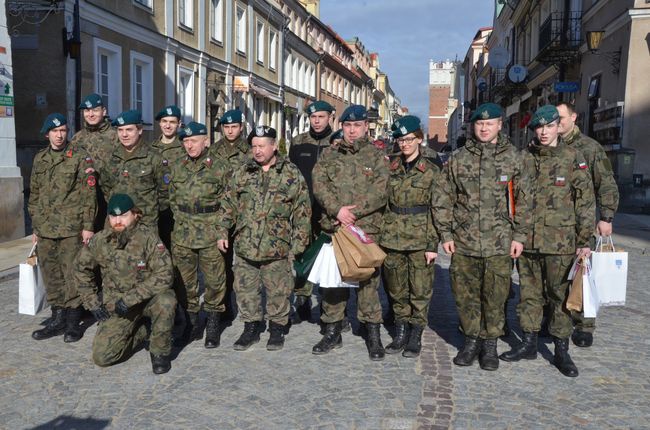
[591,236,627,306]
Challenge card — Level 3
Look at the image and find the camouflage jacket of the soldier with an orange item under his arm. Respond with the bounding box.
[436,134,531,257]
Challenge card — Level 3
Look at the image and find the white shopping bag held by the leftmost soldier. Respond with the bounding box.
[18,244,47,315]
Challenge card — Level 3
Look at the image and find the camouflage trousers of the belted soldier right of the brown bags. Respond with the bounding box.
[384,249,435,327]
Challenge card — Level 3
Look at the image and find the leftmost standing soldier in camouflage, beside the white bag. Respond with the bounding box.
[28,113,97,342]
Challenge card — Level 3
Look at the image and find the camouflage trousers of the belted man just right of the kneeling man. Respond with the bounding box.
[172,243,226,313]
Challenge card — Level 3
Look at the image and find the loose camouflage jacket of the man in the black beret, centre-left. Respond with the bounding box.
[219,156,311,261]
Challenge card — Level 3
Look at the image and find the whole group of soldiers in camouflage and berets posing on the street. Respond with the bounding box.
[29,94,618,376]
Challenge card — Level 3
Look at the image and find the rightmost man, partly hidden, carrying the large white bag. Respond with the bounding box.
[557,102,619,347]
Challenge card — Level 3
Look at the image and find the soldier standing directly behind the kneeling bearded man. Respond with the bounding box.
[98,110,169,232]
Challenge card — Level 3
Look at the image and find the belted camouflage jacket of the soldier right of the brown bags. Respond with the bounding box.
[379,154,448,252]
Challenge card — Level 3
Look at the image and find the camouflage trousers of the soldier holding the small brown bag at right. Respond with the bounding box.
[517,252,575,338]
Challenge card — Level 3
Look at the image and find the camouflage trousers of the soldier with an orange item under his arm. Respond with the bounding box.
[449,253,512,339]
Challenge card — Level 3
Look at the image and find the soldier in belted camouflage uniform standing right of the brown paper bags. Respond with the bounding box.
[379,115,446,357]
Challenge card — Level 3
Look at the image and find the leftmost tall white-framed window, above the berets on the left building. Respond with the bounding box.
[93,39,122,116]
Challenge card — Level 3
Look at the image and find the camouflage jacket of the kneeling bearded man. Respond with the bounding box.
[72,222,174,311]
